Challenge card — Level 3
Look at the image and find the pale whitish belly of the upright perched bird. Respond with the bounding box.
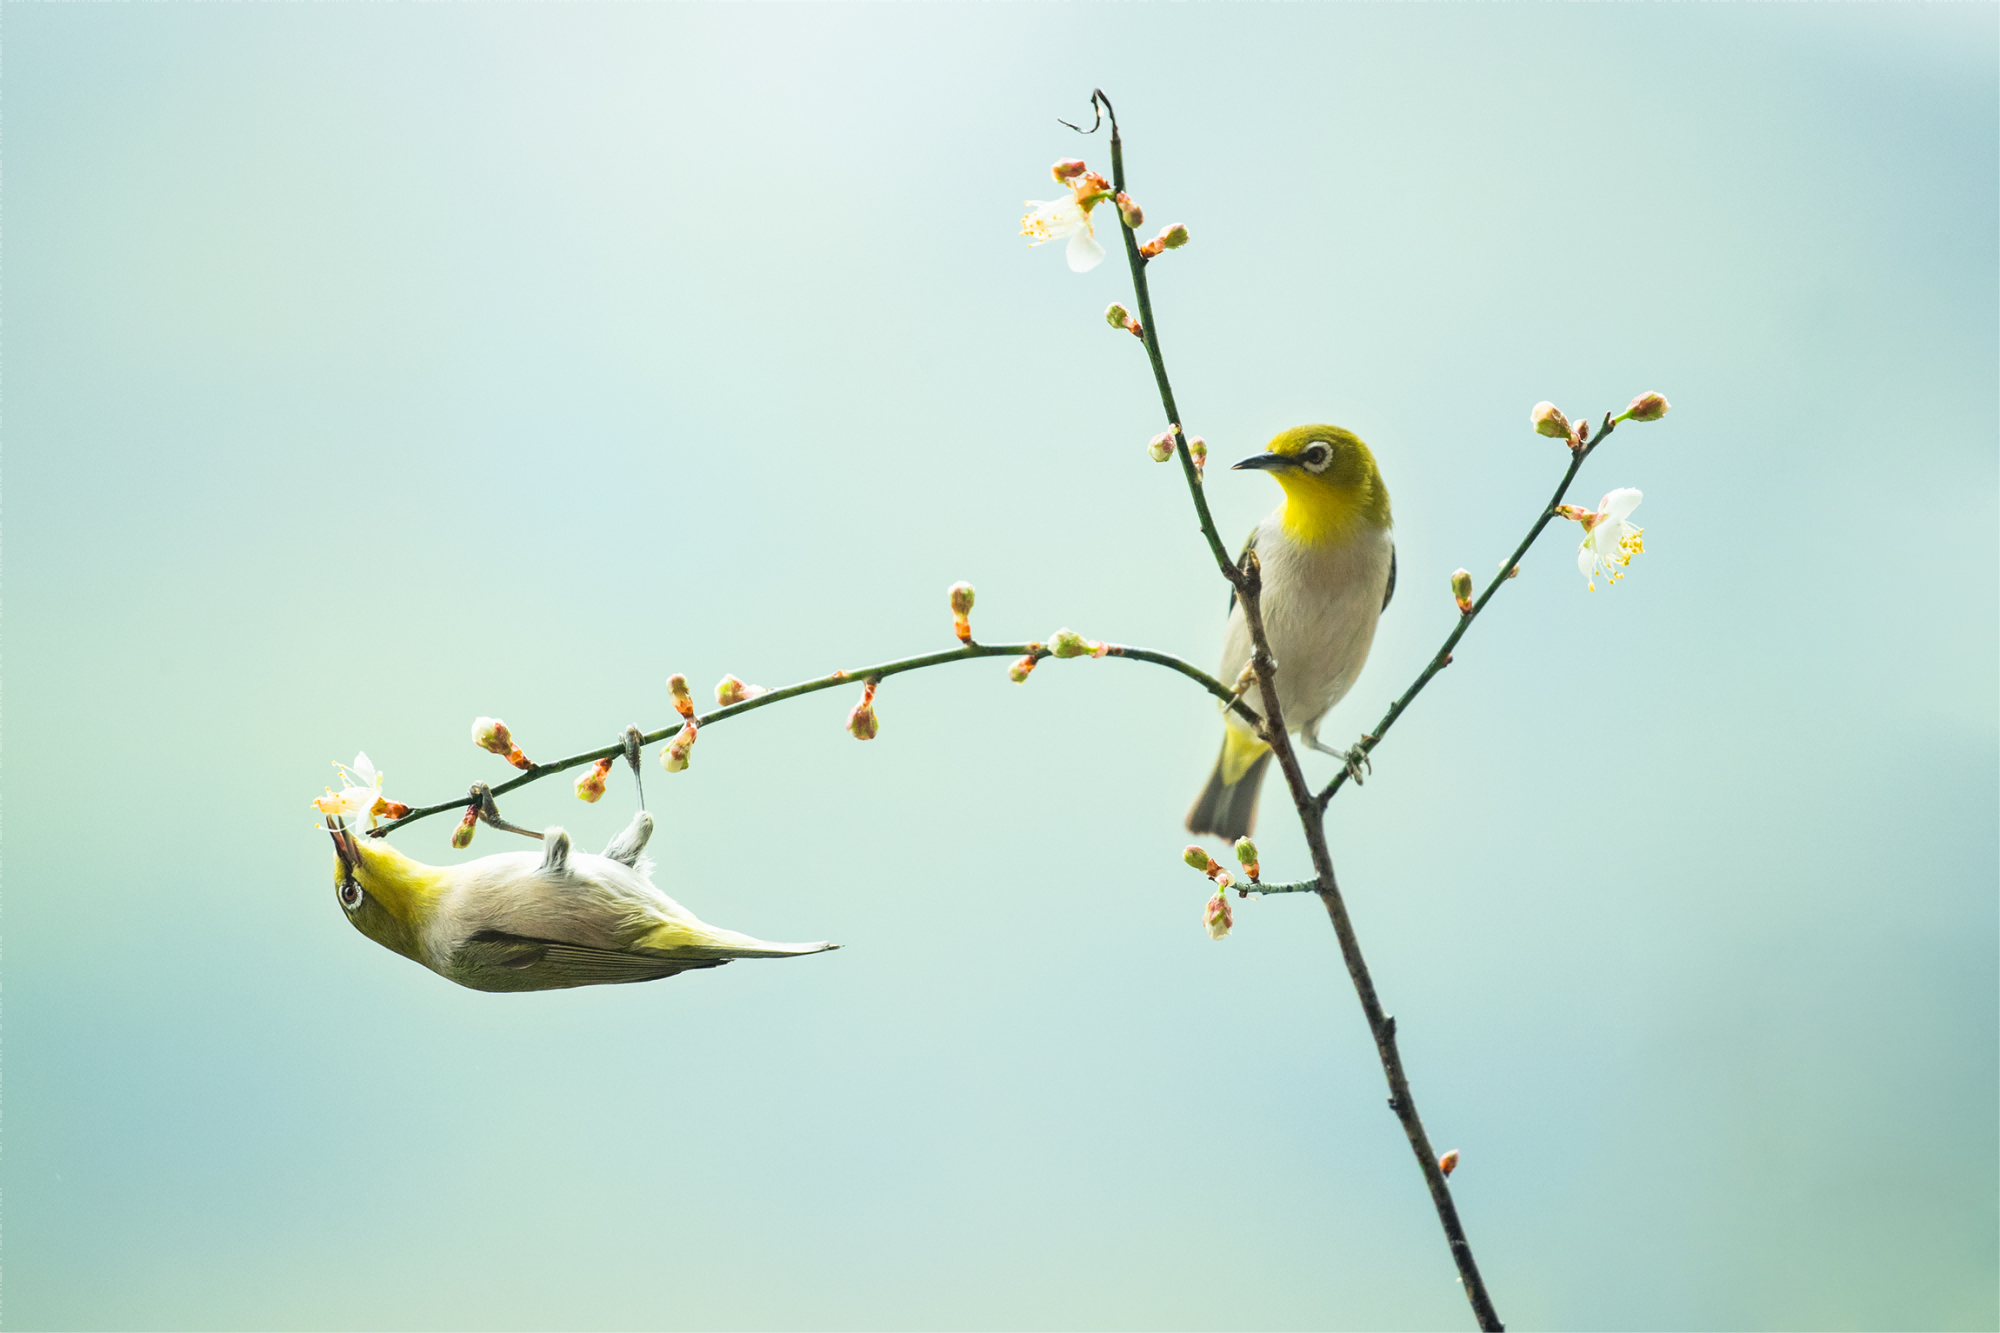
[1222,518,1392,731]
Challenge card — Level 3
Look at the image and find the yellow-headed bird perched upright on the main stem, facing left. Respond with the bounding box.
[1188,426,1396,841]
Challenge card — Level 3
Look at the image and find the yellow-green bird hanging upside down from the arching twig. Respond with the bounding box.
[330,811,840,991]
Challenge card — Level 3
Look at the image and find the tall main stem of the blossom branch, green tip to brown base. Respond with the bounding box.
[1092,90,1504,1333]
